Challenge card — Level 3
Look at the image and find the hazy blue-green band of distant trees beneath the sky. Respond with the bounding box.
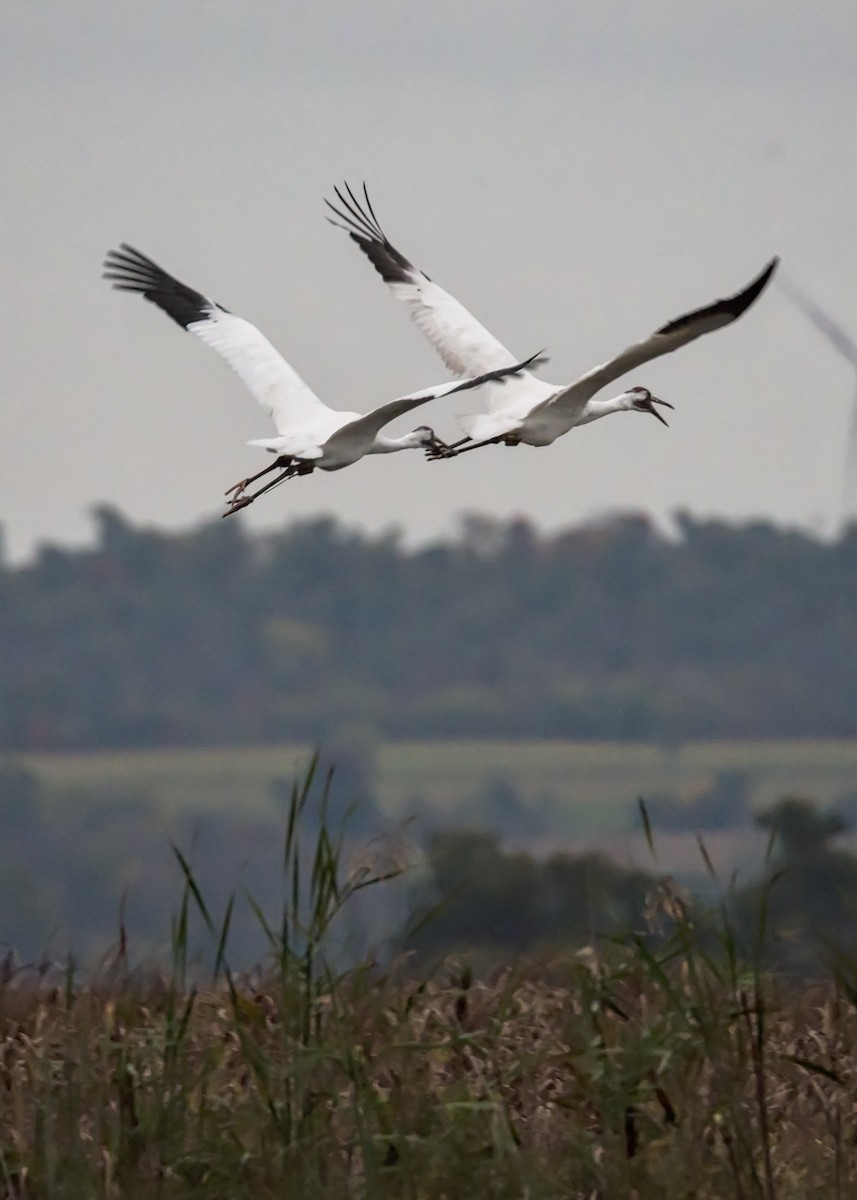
[0,508,857,750]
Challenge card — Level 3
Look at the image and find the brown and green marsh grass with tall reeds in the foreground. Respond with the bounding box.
[0,768,857,1200]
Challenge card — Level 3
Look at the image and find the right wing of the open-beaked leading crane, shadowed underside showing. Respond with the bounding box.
[533,258,779,413]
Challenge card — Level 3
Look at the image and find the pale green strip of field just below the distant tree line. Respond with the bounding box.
[16,739,857,838]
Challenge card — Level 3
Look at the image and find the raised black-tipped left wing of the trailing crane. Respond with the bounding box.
[104,242,330,433]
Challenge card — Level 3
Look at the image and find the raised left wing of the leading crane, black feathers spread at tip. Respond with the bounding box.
[324,184,514,391]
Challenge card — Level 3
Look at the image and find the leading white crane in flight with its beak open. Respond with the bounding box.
[324,184,779,458]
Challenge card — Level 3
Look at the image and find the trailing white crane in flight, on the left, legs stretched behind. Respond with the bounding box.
[103,242,546,516]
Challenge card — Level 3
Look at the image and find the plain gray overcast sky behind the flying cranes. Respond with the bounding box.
[0,0,857,557]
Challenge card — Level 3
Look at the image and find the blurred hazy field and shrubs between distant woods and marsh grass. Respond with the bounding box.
[6,726,857,961]
